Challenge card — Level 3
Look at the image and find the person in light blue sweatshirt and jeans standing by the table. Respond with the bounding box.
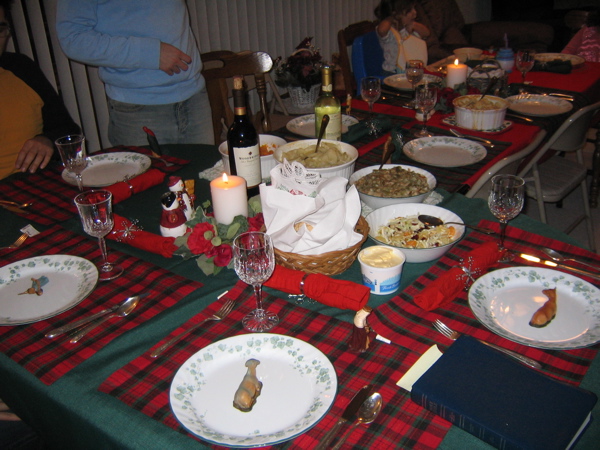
[56,0,213,145]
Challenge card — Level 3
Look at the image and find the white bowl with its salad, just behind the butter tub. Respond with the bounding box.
[366,203,465,263]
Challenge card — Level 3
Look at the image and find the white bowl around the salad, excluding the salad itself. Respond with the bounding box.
[366,203,465,263]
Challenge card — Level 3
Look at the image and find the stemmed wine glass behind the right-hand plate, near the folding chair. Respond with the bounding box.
[488,174,525,262]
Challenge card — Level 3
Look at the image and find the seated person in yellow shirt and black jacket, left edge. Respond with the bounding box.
[0,0,80,179]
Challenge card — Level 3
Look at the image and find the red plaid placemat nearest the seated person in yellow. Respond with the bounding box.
[2,146,189,225]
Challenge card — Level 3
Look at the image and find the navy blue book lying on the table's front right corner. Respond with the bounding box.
[411,335,598,450]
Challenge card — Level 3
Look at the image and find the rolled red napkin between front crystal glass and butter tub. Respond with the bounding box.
[264,265,371,311]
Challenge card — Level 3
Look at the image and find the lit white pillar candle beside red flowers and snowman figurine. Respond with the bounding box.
[210,173,248,225]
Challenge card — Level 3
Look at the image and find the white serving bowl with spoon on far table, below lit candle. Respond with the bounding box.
[452,94,508,131]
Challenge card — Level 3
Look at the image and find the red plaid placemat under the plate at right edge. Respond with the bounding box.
[369,220,600,384]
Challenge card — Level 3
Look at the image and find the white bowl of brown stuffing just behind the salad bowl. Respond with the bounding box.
[348,164,437,209]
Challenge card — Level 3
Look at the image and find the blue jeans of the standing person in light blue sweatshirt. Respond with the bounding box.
[108,89,214,146]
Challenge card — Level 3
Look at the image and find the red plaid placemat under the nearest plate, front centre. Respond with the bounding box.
[99,282,450,449]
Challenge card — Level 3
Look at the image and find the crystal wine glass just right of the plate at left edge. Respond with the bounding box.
[75,190,123,281]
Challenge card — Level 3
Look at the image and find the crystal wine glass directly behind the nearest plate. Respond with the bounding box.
[233,231,279,332]
